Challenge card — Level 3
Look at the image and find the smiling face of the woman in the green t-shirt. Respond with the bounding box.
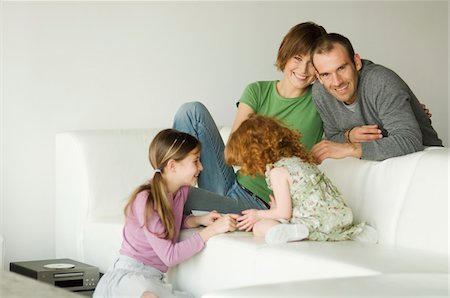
[283,55,316,89]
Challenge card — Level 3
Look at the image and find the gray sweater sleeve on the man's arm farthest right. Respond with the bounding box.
[360,68,423,160]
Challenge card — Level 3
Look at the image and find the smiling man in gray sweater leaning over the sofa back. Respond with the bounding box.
[311,33,442,163]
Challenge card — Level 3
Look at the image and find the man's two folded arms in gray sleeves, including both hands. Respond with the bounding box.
[312,68,423,162]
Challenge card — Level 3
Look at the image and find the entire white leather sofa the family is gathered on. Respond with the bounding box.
[56,129,449,298]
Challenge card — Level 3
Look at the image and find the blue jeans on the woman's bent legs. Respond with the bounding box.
[173,102,267,213]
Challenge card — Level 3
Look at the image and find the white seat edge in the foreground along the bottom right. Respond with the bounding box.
[201,273,449,298]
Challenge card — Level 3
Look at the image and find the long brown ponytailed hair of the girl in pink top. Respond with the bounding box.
[124,129,201,239]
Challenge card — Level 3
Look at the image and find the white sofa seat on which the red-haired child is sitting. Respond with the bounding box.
[168,229,447,297]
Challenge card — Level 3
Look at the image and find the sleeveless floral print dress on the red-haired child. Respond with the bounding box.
[266,157,365,241]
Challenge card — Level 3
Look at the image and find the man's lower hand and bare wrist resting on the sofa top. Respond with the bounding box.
[311,140,362,164]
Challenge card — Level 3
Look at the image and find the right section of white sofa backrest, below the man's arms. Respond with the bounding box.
[320,147,449,254]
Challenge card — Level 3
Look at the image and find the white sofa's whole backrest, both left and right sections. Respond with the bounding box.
[56,127,449,260]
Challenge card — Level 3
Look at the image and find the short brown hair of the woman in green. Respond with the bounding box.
[275,22,327,71]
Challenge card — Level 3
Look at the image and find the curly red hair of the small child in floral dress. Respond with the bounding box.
[225,114,315,176]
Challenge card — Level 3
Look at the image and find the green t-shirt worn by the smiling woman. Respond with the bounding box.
[236,81,323,203]
